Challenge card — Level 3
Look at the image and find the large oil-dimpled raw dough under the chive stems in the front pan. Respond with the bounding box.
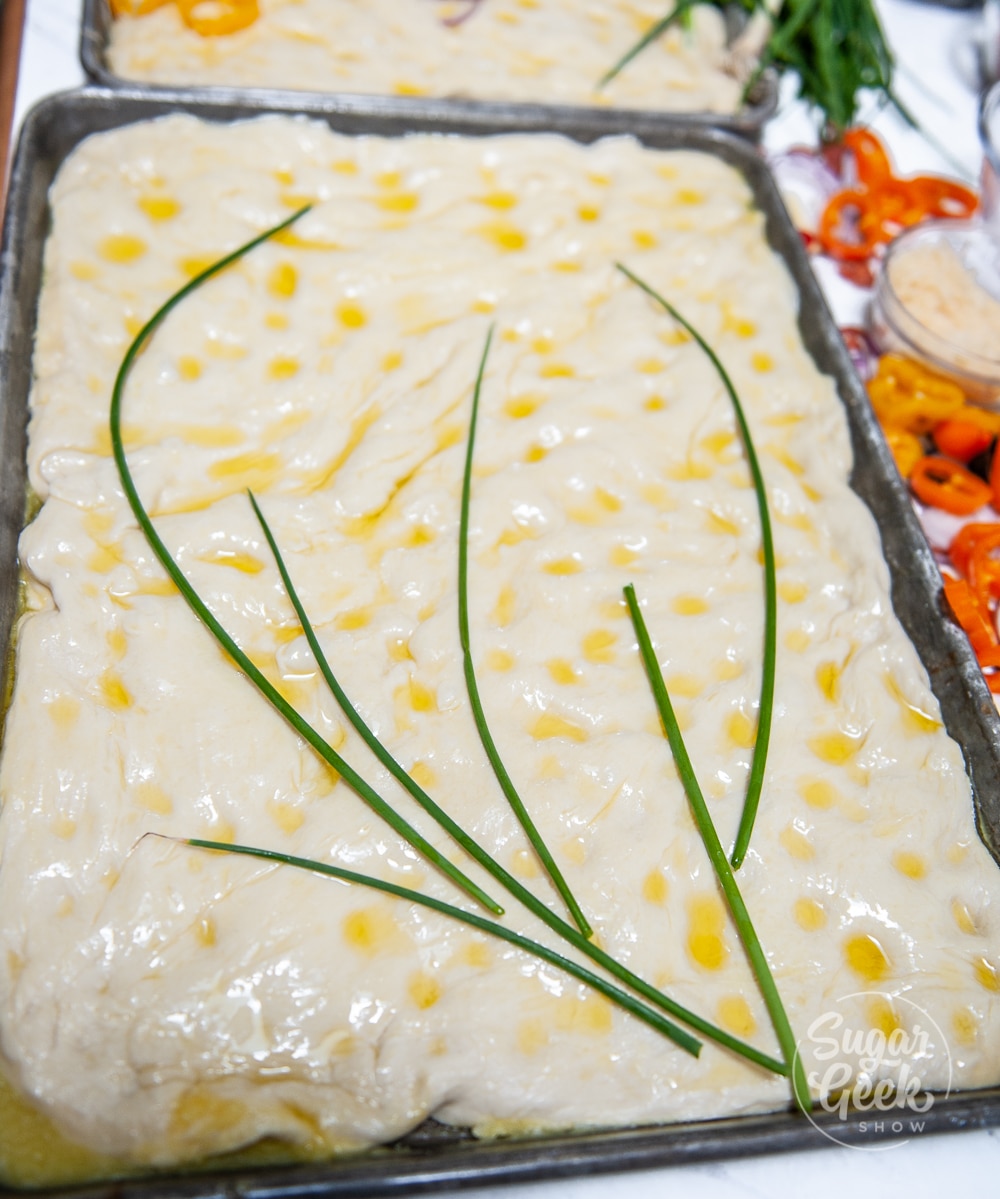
[0,116,1000,1162]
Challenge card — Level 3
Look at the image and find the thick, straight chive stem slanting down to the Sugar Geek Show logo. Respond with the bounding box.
[625,583,812,1111]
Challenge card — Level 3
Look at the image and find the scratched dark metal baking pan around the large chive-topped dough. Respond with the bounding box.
[0,82,1000,1199]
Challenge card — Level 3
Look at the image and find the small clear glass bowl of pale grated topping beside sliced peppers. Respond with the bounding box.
[871,221,1000,408]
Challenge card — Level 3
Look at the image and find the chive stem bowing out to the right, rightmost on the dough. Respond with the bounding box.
[616,263,778,869]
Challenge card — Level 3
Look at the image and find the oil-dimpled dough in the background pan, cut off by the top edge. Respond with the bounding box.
[108,0,760,113]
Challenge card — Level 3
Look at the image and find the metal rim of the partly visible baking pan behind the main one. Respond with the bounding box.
[80,0,778,141]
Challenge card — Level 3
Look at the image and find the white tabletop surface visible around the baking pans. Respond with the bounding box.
[7,0,1000,1199]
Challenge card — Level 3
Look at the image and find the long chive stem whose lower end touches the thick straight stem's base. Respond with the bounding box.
[251,496,788,1074]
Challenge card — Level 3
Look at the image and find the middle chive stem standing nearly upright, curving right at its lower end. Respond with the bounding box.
[458,326,594,938]
